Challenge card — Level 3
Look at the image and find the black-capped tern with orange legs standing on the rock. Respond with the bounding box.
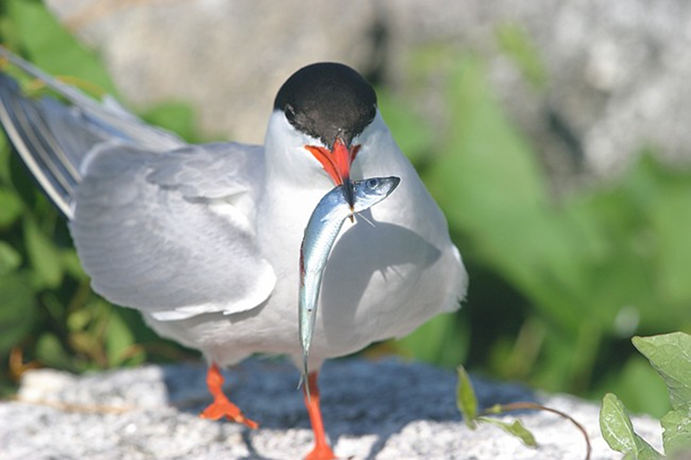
[0,47,468,460]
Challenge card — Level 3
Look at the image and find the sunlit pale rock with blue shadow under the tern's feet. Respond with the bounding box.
[0,359,660,460]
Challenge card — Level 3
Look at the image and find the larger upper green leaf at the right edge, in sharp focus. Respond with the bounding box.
[632,332,691,418]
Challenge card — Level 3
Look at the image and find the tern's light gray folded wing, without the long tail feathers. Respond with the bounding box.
[70,144,276,320]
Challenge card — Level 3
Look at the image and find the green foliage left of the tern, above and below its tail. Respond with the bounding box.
[0,0,195,391]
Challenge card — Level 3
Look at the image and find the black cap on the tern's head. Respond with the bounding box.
[274,62,377,149]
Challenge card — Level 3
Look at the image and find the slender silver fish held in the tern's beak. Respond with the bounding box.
[299,176,401,395]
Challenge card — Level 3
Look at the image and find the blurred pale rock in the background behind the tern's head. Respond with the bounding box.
[46,0,691,186]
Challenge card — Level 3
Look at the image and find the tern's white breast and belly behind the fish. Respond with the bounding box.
[143,116,467,369]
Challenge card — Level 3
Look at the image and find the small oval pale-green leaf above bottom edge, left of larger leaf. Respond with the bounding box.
[600,393,664,460]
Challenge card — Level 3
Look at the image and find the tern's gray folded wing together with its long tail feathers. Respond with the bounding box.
[0,47,276,320]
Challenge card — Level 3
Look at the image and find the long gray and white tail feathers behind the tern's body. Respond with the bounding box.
[0,46,184,218]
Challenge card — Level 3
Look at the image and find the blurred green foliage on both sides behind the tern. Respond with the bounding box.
[0,0,691,415]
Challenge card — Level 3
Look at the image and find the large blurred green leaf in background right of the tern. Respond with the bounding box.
[425,57,597,334]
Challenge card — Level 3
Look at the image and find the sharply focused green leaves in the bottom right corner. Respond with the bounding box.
[600,332,691,460]
